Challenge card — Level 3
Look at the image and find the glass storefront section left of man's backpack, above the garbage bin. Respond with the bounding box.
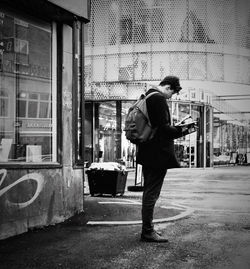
[85,101,135,167]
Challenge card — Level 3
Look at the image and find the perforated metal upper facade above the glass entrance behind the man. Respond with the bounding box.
[85,0,250,98]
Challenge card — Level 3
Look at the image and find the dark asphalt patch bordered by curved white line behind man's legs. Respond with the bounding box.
[81,170,189,225]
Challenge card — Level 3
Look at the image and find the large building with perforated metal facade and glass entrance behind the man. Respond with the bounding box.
[85,0,250,167]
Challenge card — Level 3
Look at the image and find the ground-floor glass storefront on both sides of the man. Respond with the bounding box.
[85,101,212,168]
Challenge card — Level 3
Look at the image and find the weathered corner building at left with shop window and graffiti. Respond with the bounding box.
[0,0,90,239]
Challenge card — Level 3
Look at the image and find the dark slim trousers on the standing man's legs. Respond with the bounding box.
[142,166,167,233]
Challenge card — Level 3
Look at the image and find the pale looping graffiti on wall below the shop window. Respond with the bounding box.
[0,169,45,208]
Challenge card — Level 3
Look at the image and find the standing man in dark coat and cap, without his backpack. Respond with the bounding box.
[136,76,186,242]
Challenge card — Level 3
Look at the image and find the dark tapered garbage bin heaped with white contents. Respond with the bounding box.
[86,163,128,197]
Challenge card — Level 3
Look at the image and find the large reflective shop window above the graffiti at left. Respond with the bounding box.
[0,10,57,164]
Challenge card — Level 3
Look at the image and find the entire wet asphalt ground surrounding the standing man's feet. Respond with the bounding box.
[0,167,250,269]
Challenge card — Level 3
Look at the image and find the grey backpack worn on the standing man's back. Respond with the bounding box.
[124,92,158,144]
